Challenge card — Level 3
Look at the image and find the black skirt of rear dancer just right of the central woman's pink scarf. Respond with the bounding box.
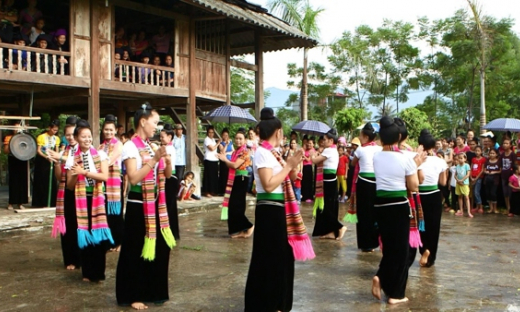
[312,174,343,237]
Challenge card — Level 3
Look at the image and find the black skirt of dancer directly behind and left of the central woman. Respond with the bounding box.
[228,175,253,235]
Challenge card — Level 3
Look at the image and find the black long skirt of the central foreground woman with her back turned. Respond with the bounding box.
[245,200,294,312]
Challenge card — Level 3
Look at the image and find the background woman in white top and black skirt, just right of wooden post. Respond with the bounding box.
[202,126,219,197]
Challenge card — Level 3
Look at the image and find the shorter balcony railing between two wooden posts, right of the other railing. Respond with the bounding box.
[114,60,175,88]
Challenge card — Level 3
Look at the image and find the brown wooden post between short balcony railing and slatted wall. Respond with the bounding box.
[186,20,202,194]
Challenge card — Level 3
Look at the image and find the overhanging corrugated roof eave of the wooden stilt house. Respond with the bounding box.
[181,0,318,55]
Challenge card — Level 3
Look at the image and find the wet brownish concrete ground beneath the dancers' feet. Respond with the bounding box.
[0,193,520,312]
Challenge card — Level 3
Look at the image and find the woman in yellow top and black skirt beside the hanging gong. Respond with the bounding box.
[32,119,60,207]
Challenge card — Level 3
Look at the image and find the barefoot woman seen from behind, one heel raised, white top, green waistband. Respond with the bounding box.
[372,116,425,304]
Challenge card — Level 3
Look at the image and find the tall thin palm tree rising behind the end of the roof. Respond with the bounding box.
[267,0,324,120]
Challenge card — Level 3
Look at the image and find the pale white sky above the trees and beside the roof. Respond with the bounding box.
[246,0,520,89]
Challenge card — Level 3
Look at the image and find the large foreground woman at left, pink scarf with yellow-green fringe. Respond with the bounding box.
[116,104,175,310]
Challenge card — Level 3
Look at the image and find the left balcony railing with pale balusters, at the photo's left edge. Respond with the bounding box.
[0,43,70,76]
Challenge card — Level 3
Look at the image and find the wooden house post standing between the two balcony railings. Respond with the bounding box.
[88,0,100,146]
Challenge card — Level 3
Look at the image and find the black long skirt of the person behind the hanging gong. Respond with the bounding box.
[7,155,29,205]
